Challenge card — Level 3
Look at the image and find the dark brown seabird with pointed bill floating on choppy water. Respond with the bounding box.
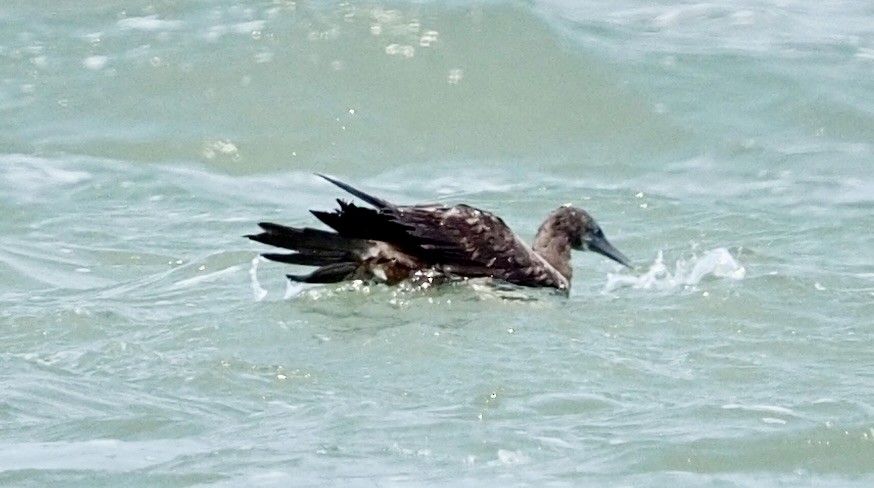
[244,173,632,294]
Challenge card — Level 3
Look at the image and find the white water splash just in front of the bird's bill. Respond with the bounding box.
[604,247,746,293]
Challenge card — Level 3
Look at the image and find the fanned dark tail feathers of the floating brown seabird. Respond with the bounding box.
[246,222,369,283]
